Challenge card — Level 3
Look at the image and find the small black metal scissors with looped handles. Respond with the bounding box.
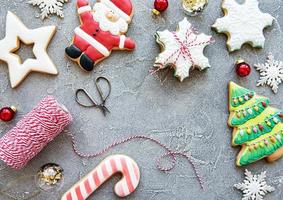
[76,76,111,116]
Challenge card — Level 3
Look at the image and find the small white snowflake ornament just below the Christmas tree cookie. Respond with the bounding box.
[234,170,275,200]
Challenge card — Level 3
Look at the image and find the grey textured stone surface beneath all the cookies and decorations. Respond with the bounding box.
[0,0,283,200]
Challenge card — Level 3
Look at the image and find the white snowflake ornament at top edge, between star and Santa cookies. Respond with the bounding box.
[28,0,69,19]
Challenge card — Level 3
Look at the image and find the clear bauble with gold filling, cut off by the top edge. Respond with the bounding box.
[182,0,208,16]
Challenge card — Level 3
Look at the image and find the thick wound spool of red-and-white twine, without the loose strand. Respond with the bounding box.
[0,96,72,169]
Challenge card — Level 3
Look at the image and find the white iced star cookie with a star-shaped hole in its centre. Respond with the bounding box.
[0,12,58,88]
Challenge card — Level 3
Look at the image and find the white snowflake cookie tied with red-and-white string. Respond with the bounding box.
[154,18,213,81]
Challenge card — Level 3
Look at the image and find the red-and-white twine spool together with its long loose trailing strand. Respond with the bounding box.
[0,96,203,188]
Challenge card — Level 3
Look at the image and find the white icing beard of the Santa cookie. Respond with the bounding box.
[93,3,128,35]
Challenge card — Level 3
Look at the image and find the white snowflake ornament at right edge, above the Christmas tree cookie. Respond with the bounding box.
[255,53,283,93]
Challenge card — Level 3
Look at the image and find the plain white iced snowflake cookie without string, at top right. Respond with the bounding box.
[212,0,274,52]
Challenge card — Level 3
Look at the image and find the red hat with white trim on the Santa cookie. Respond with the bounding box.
[100,0,133,22]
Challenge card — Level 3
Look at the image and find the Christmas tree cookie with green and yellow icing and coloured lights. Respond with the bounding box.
[228,82,283,166]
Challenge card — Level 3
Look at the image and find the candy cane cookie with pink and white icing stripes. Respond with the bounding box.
[61,155,140,200]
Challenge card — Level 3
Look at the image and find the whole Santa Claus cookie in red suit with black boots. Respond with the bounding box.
[65,0,138,71]
